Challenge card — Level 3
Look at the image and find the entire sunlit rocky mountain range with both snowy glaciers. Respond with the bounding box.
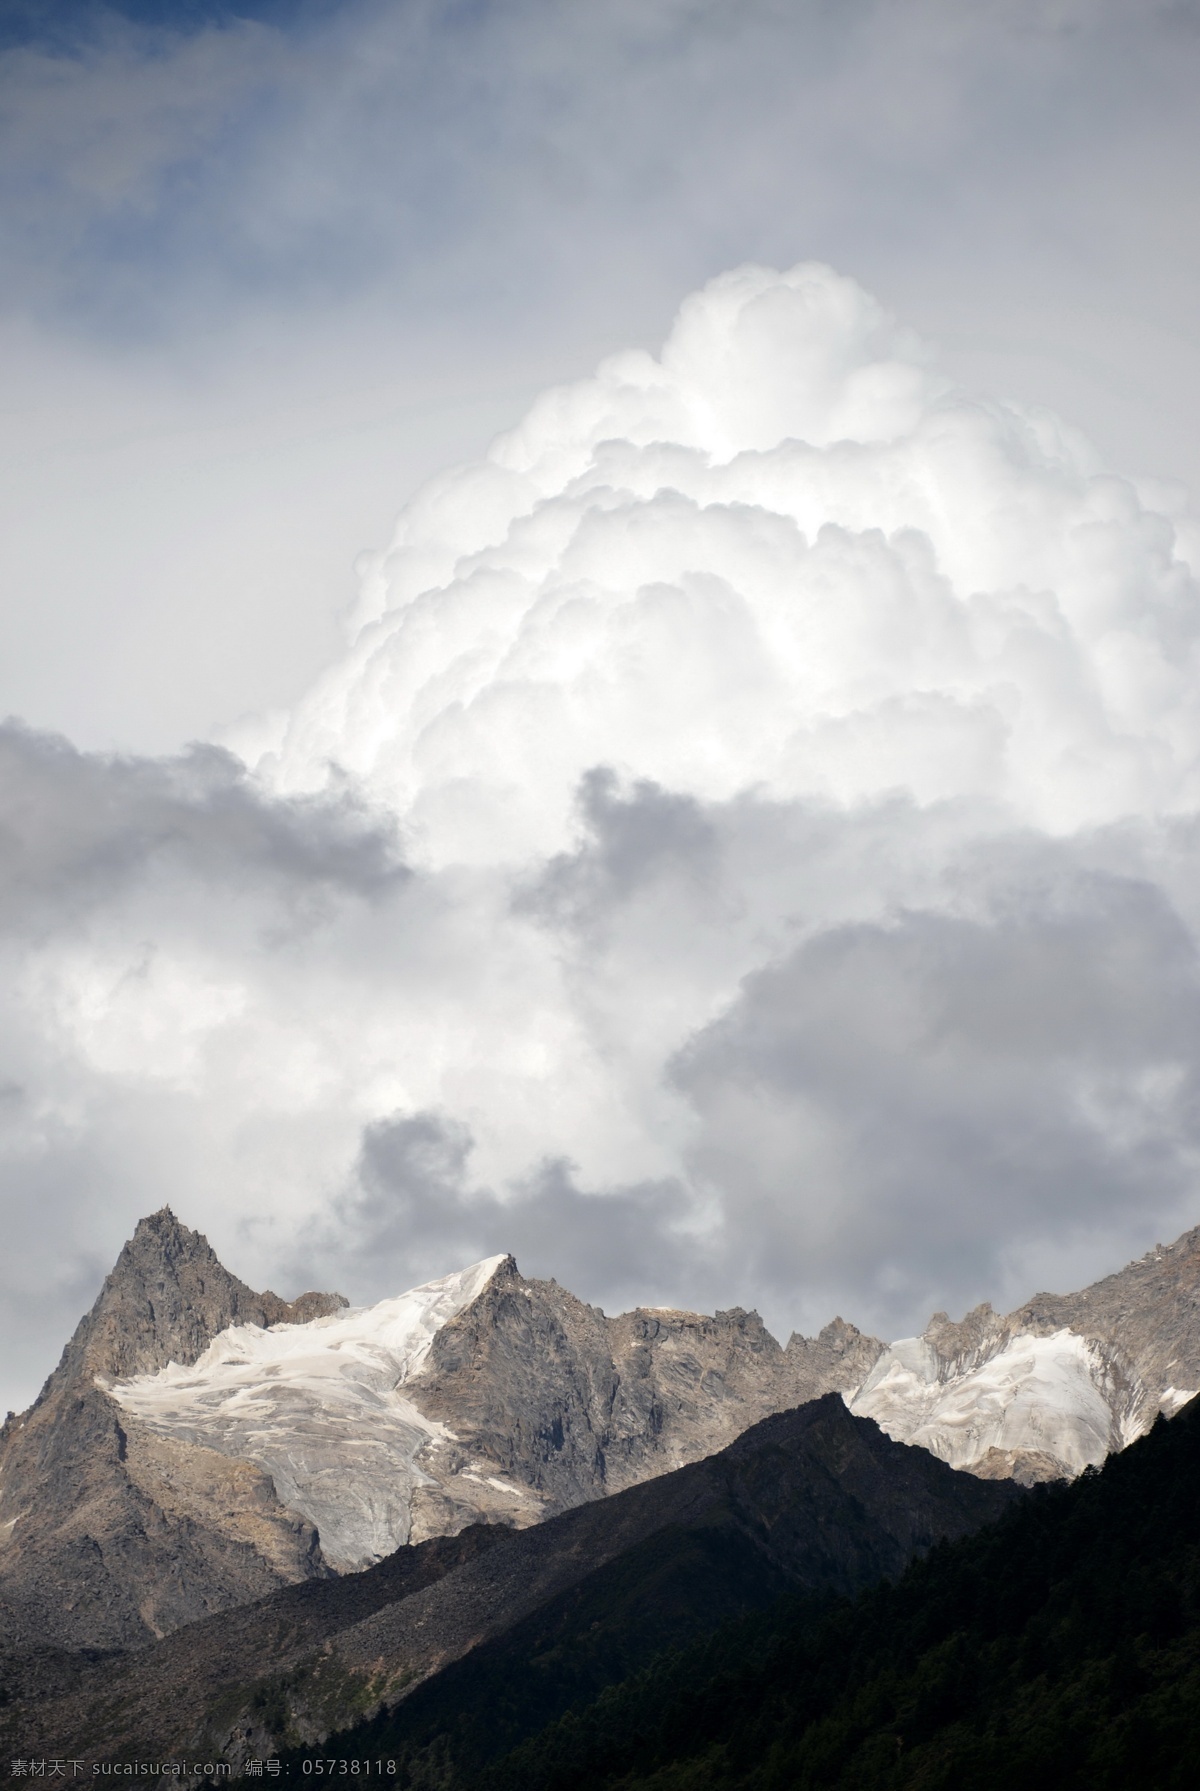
[0,1209,1200,1648]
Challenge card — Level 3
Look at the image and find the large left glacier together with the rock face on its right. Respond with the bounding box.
[100,1255,883,1572]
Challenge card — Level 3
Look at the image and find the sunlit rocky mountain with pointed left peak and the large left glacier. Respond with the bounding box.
[0,1209,883,1648]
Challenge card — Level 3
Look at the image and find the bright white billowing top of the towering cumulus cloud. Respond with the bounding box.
[261,265,1200,845]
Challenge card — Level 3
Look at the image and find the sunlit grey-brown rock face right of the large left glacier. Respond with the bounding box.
[408,1257,883,1535]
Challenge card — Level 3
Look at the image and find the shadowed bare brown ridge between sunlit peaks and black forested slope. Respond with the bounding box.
[4,1396,1019,1762]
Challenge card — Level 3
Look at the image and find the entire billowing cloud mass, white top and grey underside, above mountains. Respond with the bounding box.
[2,265,1200,1411]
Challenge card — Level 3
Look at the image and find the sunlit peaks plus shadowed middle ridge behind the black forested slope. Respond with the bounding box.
[0,1209,1200,1784]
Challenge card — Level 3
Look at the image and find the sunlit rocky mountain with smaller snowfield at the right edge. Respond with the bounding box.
[851,1229,1200,1483]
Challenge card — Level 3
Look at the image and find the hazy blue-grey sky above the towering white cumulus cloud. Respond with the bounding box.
[0,0,1200,752]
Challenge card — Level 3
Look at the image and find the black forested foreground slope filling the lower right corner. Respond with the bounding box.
[476,1401,1200,1791]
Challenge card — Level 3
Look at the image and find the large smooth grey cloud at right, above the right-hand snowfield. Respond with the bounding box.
[672,870,1200,1316]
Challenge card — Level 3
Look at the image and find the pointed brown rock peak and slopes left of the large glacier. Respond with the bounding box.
[0,1209,344,1648]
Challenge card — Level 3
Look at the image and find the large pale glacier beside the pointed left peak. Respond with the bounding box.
[106,1255,512,1572]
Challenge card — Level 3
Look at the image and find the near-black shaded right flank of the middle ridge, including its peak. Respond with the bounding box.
[279,1395,1024,1786]
